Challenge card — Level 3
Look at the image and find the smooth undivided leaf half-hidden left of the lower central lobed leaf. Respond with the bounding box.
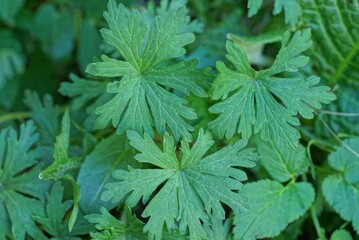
[77,134,139,213]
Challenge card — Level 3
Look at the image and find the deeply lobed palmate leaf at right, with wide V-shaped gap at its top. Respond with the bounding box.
[209,29,335,147]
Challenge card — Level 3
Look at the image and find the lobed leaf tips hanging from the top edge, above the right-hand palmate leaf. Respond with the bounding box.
[248,0,305,26]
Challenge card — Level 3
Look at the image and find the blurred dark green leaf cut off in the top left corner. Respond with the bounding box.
[0,0,25,25]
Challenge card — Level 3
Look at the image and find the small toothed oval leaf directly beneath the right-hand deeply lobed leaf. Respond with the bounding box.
[257,140,309,182]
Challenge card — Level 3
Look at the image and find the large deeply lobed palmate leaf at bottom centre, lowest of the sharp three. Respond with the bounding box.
[102,129,258,239]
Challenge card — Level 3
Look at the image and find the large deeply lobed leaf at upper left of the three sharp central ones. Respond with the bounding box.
[86,0,212,140]
